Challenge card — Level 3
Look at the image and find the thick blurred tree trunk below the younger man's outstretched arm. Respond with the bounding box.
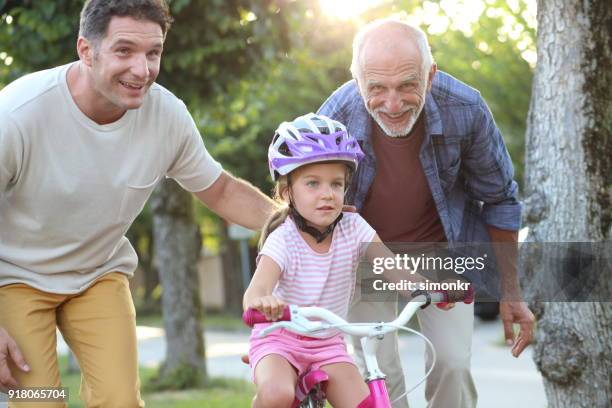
[151,180,206,389]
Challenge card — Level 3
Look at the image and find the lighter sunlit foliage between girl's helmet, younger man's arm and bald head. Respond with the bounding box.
[196,2,353,191]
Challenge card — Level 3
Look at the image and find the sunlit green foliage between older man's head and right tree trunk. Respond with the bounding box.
[416,1,535,183]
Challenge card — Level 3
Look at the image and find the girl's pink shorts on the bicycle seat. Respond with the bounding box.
[249,325,355,380]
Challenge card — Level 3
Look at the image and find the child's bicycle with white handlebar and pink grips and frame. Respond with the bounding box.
[243,286,474,408]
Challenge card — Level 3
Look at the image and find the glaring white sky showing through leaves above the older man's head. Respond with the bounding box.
[319,0,537,67]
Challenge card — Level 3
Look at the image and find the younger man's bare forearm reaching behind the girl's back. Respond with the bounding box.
[194,171,276,230]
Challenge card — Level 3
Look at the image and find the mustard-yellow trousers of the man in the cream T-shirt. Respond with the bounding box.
[0,273,144,408]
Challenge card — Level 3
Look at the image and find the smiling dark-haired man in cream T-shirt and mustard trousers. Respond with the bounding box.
[0,0,273,408]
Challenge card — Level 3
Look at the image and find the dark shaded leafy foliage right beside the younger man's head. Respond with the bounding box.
[158,0,287,109]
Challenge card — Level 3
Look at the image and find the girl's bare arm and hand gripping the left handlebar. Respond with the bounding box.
[242,255,285,320]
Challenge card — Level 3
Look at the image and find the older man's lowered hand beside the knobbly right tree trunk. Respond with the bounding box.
[499,301,535,357]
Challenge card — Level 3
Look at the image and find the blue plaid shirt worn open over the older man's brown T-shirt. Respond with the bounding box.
[319,71,521,247]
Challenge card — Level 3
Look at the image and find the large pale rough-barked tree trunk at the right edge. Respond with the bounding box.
[522,0,612,408]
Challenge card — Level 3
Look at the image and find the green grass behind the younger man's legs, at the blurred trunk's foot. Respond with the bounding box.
[60,356,255,408]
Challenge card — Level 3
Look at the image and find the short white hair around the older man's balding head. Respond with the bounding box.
[351,17,434,80]
